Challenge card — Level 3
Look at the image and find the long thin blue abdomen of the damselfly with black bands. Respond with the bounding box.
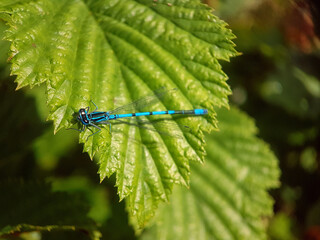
[109,109,208,120]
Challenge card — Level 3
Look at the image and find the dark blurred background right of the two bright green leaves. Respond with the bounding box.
[205,0,320,240]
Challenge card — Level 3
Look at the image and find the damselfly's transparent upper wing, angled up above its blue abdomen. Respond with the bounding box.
[109,87,177,114]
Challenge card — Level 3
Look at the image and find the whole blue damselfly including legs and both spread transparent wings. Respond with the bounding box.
[73,88,208,139]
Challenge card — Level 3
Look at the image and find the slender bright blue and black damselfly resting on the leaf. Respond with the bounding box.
[77,89,208,138]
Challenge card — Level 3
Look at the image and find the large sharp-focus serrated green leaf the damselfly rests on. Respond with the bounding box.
[0,0,236,226]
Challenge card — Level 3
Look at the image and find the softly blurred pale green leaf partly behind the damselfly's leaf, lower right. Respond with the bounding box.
[142,109,279,240]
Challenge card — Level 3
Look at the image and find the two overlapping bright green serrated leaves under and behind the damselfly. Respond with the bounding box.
[0,0,279,239]
